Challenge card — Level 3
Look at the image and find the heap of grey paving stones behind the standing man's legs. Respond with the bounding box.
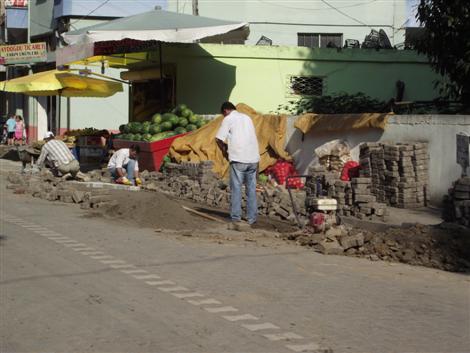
[142,161,307,221]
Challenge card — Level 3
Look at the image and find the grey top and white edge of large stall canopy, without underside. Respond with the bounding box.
[62,10,248,45]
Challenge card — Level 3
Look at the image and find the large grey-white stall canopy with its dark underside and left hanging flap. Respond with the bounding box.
[56,10,249,66]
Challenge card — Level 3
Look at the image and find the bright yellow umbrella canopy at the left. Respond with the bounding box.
[0,70,123,97]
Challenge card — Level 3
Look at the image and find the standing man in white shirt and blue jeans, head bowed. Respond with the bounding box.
[216,102,260,225]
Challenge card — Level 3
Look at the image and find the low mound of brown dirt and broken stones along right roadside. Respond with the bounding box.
[287,223,470,272]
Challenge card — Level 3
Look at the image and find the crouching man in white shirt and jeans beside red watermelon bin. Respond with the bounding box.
[108,145,142,185]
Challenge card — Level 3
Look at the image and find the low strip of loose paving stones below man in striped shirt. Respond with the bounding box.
[7,169,115,209]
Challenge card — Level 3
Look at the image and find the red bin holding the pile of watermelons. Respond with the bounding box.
[113,134,186,172]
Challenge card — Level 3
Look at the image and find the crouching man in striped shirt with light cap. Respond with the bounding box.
[37,131,80,178]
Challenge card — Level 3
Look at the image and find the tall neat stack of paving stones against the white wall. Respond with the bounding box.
[360,143,429,208]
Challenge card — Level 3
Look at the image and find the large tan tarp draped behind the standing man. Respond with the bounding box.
[169,103,291,177]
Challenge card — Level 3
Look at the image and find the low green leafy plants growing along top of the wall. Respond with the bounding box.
[278,93,390,115]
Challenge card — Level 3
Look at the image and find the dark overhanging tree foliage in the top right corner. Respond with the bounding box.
[415,0,470,106]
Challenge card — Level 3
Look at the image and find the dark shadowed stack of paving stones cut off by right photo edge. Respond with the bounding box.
[443,176,470,228]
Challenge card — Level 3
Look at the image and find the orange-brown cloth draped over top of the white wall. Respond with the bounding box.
[294,113,392,134]
